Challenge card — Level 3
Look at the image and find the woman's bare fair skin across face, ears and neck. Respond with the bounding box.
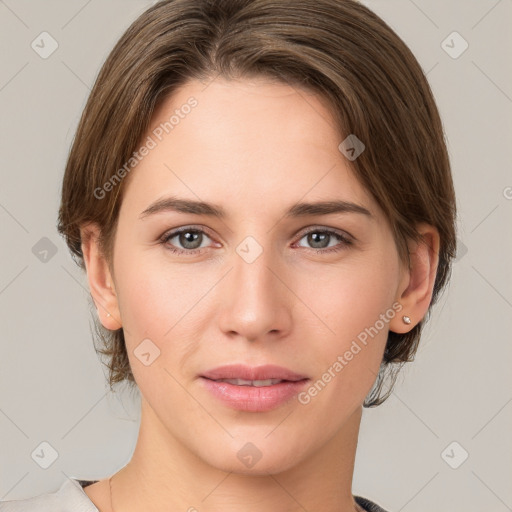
[82,78,439,512]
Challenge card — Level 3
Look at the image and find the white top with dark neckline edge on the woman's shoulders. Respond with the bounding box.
[0,477,386,512]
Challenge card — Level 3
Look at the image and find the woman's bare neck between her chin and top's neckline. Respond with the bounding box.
[111,399,362,512]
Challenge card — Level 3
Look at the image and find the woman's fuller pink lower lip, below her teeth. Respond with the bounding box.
[201,377,309,412]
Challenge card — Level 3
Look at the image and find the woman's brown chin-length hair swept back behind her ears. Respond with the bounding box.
[58,0,456,407]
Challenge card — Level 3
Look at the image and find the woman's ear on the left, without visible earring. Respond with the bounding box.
[80,223,122,331]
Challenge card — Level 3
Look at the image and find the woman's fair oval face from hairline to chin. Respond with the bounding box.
[105,79,403,473]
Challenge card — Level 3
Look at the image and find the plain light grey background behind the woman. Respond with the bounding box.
[0,0,512,512]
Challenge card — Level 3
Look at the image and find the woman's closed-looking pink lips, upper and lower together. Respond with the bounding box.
[200,365,309,412]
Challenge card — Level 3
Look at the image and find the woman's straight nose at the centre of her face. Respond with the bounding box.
[217,241,294,341]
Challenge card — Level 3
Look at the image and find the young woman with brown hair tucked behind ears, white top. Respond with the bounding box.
[0,0,456,512]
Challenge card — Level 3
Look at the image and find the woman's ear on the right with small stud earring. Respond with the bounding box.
[390,223,440,333]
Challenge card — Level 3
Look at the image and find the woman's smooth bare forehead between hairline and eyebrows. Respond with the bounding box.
[120,78,375,215]
